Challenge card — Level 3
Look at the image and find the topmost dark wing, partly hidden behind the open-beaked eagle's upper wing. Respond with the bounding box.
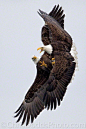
[41,5,65,45]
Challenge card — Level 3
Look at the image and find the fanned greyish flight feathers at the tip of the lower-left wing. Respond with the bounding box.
[15,95,44,126]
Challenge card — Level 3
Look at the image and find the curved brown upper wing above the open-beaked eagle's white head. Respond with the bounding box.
[38,6,72,48]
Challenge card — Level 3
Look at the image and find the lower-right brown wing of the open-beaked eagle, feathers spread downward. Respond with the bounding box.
[43,53,76,110]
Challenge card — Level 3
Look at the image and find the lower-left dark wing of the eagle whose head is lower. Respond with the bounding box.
[15,63,50,126]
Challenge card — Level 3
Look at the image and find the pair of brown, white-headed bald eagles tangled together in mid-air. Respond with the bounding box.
[15,5,76,126]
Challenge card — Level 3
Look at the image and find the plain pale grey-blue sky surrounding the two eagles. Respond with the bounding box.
[0,0,86,129]
